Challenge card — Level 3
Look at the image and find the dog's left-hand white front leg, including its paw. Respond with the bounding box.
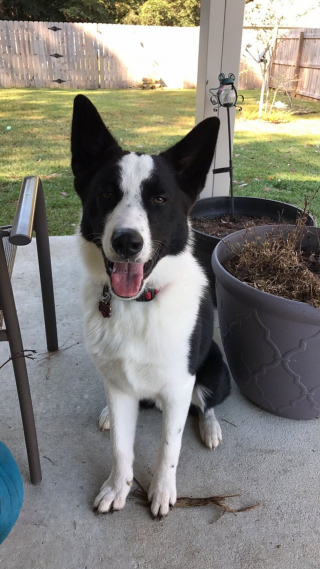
[93,387,138,514]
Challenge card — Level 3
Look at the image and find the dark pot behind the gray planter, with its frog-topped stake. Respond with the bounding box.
[191,73,314,297]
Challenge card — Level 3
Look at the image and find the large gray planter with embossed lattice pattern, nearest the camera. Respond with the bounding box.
[212,226,320,419]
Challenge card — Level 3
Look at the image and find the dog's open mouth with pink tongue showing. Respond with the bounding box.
[105,257,154,298]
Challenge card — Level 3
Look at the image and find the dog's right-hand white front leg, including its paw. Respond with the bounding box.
[148,376,194,517]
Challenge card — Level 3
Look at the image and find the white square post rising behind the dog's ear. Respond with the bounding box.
[196,0,245,198]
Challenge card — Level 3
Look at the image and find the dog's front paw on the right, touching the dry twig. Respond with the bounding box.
[148,472,177,519]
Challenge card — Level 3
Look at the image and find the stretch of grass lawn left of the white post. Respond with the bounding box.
[0,89,195,235]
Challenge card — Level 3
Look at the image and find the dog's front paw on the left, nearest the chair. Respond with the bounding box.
[93,477,132,514]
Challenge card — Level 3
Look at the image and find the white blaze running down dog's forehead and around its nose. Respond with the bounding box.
[102,153,154,263]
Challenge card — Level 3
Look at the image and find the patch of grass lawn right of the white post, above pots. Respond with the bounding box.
[234,91,320,218]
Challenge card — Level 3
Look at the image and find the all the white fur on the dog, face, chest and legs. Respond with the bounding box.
[80,154,221,516]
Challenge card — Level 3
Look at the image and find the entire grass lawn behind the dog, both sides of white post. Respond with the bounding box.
[0,89,320,235]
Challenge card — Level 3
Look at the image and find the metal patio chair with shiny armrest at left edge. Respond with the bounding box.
[0,176,58,484]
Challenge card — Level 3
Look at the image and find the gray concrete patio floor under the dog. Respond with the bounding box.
[0,233,320,569]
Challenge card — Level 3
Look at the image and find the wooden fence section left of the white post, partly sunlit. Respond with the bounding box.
[0,20,199,89]
